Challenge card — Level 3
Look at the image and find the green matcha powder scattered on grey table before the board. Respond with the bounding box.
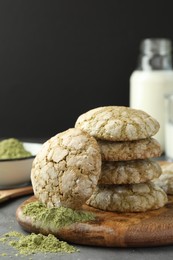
[0,231,78,255]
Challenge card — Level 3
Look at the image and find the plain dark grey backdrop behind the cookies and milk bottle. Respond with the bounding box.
[0,0,173,138]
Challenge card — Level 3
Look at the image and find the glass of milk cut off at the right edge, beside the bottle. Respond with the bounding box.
[165,93,173,161]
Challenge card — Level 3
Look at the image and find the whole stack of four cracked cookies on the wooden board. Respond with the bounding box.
[75,106,167,212]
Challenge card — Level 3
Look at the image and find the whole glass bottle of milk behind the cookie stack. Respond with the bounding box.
[129,38,173,151]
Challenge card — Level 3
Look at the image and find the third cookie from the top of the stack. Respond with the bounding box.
[98,159,162,184]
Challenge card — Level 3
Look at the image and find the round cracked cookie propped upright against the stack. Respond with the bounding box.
[31,128,101,208]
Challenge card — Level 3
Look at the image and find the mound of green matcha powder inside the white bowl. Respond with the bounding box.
[0,138,32,160]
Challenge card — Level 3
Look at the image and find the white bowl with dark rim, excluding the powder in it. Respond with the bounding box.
[0,142,42,188]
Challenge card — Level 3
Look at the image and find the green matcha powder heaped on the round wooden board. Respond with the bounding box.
[23,201,95,228]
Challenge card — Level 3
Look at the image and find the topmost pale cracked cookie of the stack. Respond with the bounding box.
[75,106,160,141]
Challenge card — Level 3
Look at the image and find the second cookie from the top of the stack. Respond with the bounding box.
[98,138,162,161]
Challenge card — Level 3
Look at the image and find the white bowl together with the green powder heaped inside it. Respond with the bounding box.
[0,139,42,188]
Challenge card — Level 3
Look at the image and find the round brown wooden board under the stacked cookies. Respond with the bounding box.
[16,196,173,247]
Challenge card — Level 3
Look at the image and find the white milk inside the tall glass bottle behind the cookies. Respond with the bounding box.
[130,70,173,151]
